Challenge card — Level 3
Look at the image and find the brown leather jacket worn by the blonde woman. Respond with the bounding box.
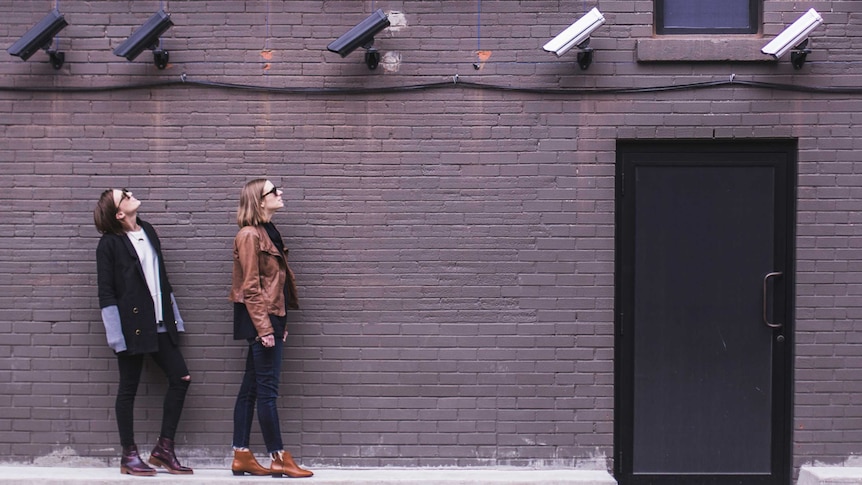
[229,226,299,337]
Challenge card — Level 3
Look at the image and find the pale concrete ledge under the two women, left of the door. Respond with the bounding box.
[0,466,617,485]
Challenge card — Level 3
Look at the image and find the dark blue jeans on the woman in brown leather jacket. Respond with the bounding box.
[233,335,284,453]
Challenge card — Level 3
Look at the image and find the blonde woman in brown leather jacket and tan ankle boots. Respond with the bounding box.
[230,179,313,478]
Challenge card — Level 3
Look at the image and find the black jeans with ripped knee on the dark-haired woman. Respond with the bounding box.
[116,333,189,446]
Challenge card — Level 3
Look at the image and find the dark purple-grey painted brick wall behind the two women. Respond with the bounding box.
[0,0,862,468]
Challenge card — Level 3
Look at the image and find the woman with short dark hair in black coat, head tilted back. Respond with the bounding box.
[93,189,193,476]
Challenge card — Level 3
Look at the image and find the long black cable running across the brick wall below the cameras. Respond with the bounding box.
[0,74,862,95]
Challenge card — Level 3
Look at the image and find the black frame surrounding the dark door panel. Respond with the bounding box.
[613,139,798,485]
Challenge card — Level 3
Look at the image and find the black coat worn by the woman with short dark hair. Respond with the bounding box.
[96,219,179,354]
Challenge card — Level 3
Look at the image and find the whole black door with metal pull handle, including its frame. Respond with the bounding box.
[614,141,796,485]
